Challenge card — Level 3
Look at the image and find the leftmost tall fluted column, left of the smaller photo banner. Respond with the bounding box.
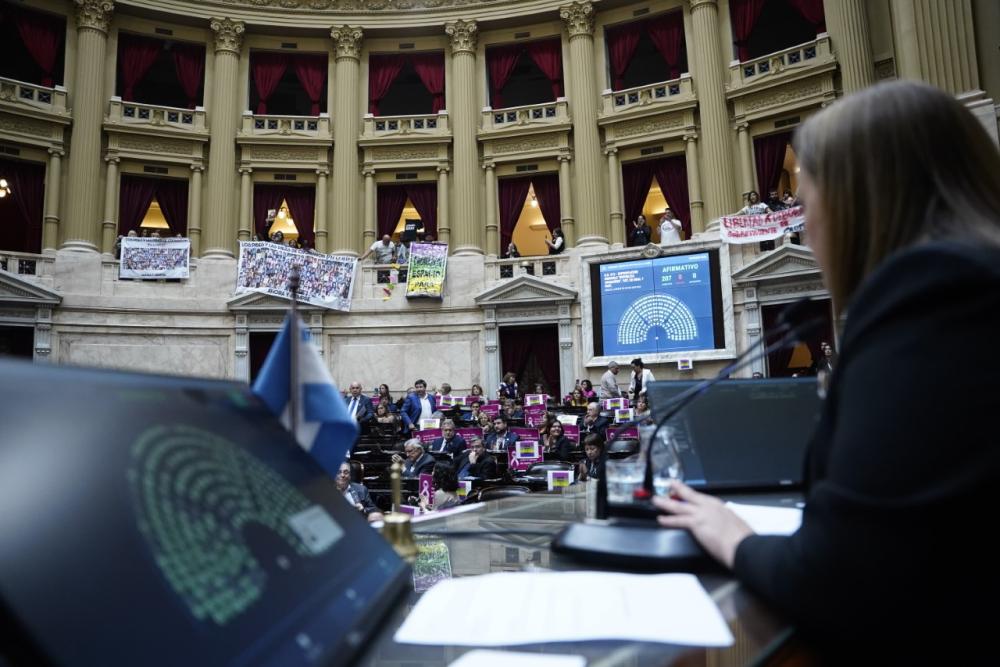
[61,0,115,252]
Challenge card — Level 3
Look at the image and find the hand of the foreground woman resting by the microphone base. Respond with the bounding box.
[653,481,753,569]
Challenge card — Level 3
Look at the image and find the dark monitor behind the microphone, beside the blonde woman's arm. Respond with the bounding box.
[647,377,821,490]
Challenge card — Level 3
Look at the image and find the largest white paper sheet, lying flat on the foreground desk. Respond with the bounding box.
[394,572,733,646]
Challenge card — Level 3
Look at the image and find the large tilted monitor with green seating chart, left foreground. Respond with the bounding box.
[0,360,408,665]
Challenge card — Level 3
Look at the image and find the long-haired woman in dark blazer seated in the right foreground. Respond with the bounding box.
[655,81,1000,665]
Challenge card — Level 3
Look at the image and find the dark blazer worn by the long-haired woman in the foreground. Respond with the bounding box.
[734,242,1000,664]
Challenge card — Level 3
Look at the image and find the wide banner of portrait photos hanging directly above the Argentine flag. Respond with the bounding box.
[236,241,358,311]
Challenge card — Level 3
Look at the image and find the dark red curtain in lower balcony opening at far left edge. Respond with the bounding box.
[0,160,45,254]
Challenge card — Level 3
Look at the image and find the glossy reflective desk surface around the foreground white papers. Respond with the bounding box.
[356,485,797,667]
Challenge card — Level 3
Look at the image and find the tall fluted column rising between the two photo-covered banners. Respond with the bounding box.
[203,18,246,259]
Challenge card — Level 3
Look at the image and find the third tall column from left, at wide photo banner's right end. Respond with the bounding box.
[329,25,362,256]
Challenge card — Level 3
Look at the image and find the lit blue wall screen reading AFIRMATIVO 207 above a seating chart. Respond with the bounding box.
[600,252,715,355]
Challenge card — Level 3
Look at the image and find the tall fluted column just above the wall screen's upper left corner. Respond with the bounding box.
[559,1,610,246]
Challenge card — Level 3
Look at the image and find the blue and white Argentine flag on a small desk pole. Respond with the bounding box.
[251,316,358,477]
